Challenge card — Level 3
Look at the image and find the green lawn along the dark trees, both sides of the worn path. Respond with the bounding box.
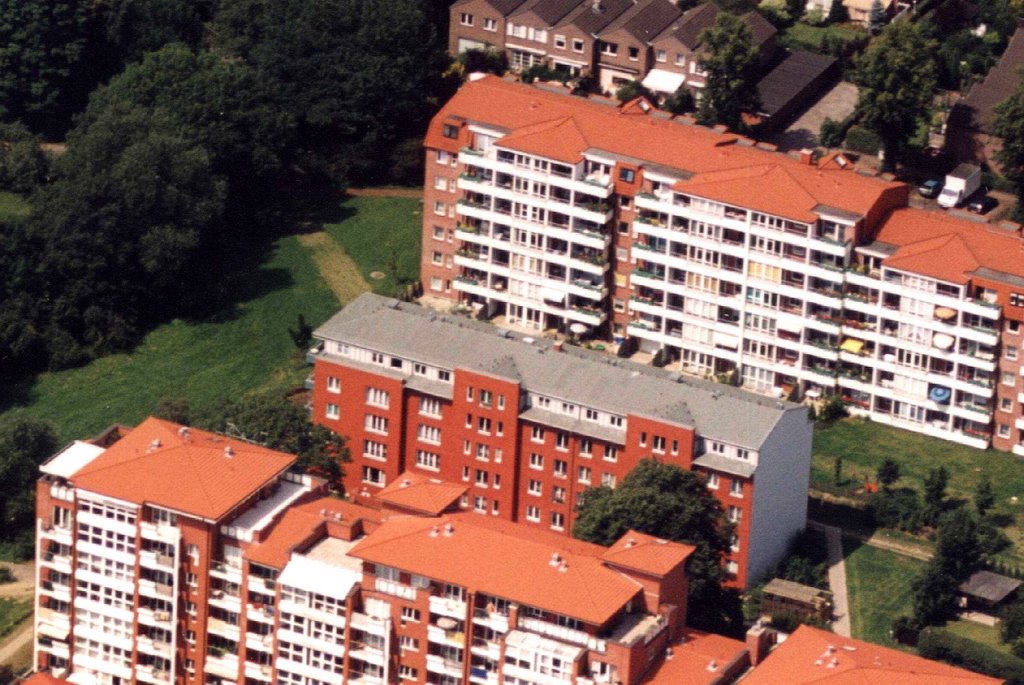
[0,198,420,440]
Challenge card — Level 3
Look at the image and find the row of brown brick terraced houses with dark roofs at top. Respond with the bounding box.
[449,0,776,94]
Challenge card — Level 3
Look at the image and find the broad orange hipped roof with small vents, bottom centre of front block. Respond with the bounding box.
[349,516,641,626]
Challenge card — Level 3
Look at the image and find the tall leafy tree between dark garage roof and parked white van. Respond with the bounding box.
[853,22,936,169]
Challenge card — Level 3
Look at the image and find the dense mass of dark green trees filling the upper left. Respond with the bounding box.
[0,0,457,374]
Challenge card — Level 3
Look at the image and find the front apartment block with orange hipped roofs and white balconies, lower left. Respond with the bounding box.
[34,419,704,685]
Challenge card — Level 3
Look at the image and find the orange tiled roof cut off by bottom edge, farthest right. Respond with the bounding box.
[743,626,1004,685]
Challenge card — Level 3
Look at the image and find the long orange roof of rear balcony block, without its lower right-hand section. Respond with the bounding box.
[426,76,903,221]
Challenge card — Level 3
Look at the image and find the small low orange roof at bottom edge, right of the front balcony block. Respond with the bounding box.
[644,629,749,685]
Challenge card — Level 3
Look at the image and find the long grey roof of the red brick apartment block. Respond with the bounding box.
[314,294,806,449]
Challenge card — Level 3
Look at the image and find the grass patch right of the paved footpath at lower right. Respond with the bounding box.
[843,540,925,645]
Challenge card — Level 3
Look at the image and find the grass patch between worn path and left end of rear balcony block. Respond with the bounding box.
[325,197,423,295]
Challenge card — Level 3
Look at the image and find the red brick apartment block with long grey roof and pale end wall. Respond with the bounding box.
[312,295,811,587]
